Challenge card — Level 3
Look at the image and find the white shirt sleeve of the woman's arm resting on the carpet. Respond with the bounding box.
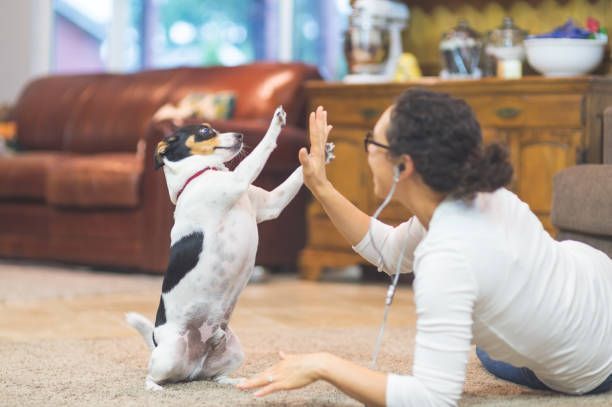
[386,248,477,406]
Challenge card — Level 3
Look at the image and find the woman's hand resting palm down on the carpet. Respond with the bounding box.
[238,352,328,397]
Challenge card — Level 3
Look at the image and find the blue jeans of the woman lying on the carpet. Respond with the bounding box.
[476,347,612,394]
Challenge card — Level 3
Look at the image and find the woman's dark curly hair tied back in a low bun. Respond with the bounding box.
[387,88,512,199]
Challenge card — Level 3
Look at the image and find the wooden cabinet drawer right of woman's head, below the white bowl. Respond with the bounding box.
[466,95,582,128]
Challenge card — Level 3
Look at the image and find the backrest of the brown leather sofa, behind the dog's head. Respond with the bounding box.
[15,63,320,154]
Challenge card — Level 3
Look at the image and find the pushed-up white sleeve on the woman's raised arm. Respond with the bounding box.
[353,216,426,275]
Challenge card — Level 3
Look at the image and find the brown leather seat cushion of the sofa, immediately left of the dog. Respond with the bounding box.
[46,153,143,208]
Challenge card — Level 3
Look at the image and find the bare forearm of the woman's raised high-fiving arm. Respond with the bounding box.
[311,181,370,246]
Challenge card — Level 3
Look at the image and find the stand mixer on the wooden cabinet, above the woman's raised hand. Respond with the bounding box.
[343,0,410,83]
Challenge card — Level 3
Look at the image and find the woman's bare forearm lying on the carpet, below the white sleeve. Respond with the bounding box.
[319,354,387,406]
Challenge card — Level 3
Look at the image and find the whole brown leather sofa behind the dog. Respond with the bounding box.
[0,63,320,272]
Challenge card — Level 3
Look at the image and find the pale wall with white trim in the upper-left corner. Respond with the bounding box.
[0,0,52,104]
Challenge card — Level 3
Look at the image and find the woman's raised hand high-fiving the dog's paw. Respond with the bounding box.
[299,106,332,196]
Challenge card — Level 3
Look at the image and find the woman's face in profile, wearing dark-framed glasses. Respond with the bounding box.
[368,107,393,198]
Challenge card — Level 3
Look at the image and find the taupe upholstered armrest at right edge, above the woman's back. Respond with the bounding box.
[552,164,612,236]
